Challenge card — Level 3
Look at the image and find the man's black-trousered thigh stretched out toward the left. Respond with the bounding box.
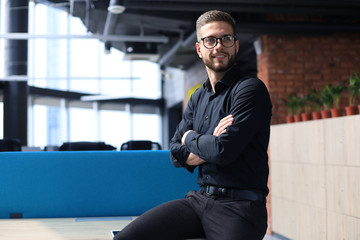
[114,199,204,240]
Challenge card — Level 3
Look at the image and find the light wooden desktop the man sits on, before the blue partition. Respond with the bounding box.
[0,217,284,240]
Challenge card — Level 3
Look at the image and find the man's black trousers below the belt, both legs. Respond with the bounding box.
[114,191,267,240]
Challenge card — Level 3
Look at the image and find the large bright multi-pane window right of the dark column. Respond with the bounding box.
[22,2,161,148]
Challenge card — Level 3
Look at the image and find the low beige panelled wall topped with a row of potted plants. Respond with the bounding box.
[270,115,360,240]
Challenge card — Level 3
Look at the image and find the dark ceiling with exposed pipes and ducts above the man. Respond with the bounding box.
[35,0,360,69]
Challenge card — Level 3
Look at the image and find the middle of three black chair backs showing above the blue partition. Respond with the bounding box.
[59,142,116,151]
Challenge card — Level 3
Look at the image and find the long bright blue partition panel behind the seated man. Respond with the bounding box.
[0,150,198,218]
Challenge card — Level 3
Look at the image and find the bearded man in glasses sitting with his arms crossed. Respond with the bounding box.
[114,10,271,240]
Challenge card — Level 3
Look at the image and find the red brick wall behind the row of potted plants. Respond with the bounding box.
[258,34,360,124]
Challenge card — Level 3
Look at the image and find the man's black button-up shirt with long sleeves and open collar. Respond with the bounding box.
[170,65,272,194]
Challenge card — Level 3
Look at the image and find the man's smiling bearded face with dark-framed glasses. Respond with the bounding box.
[196,22,239,72]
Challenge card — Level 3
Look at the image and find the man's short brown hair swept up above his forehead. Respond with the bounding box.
[196,10,236,40]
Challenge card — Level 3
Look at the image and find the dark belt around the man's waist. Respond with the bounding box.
[200,185,266,201]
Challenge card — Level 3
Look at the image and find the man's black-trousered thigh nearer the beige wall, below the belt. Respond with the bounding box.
[203,197,267,240]
